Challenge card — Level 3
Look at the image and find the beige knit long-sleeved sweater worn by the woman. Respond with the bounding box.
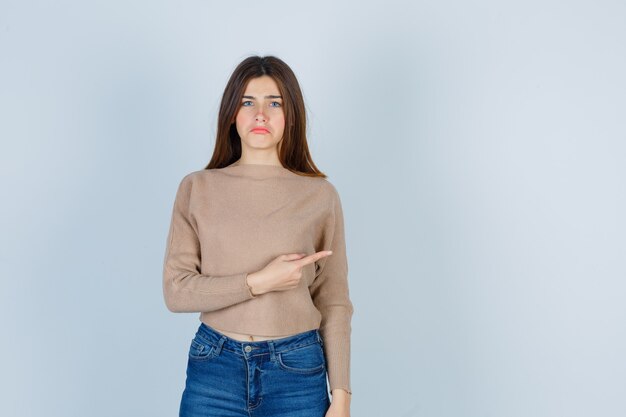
[163,164,354,392]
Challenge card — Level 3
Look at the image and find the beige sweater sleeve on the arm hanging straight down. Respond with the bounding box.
[310,184,354,393]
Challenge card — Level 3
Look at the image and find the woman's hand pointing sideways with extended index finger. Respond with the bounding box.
[248,250,333,295]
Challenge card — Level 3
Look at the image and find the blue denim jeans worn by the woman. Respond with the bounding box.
[180,323,330,417]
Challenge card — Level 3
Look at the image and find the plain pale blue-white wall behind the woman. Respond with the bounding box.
[0,0,626,417]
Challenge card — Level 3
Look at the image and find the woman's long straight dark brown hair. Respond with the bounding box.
[205,55,326,178]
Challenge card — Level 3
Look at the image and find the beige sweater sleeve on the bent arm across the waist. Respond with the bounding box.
[163,175,257,313]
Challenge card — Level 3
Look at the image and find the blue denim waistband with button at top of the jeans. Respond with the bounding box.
[196,322,324,356]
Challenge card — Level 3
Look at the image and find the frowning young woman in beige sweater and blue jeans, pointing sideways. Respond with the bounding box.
[163,56,353,417]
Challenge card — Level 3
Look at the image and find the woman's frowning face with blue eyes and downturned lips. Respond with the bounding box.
[235,75,285,153]
